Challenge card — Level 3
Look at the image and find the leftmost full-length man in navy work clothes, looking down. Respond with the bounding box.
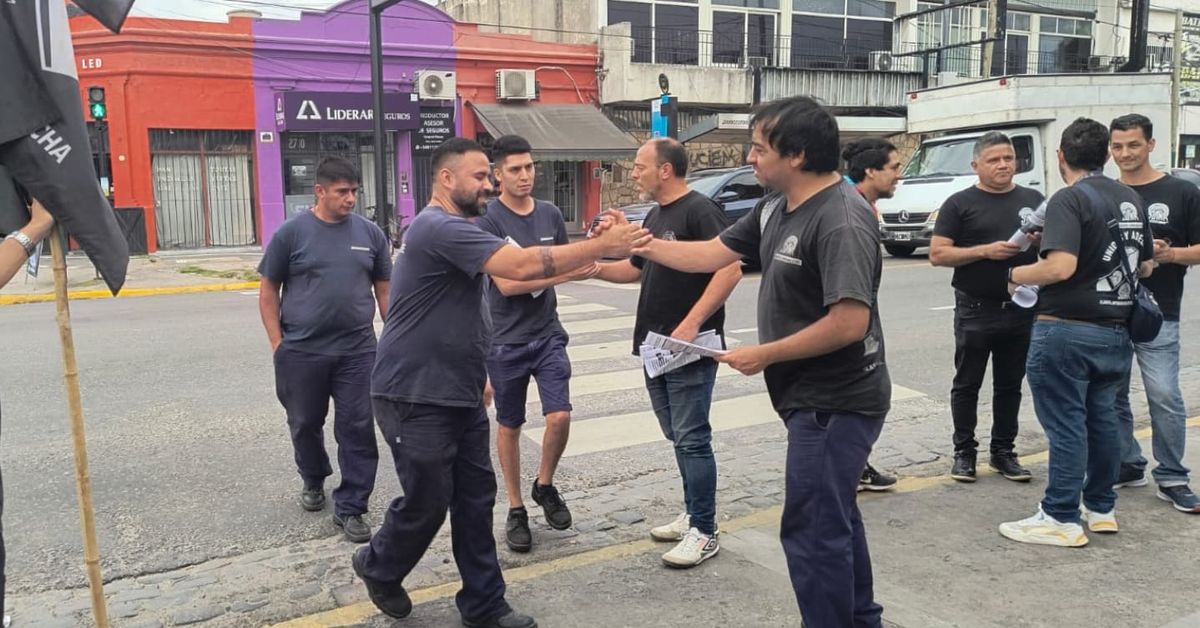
[258,157,391,543]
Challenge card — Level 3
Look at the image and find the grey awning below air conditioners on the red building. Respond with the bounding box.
[470,103,637,161]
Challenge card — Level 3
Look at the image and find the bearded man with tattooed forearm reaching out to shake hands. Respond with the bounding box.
[353,138,643,628]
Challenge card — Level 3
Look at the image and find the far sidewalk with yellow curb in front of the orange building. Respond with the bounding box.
[0,246,263,305]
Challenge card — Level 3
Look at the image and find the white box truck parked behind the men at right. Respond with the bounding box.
[876,73,1171,257]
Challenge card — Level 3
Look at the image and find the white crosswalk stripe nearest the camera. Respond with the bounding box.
[523,393,782,457]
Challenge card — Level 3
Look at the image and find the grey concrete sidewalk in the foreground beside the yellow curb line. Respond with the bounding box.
[280,419,1200,628]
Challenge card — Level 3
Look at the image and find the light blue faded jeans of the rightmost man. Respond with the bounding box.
[1117,321,1190,486]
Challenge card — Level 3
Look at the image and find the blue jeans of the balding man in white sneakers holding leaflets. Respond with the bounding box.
[646,358,715,534]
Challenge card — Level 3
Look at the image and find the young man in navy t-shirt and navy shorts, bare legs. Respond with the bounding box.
[475,136,599,552]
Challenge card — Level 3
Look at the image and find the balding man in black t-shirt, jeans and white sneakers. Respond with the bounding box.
[598,138,742,568]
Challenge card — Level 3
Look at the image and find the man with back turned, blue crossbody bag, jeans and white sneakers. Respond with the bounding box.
[1000,118,1153,548]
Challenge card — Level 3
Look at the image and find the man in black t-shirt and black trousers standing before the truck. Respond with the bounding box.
[929,131,1043,483]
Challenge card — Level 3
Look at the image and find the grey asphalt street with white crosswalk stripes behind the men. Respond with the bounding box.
[0,250,1200,624]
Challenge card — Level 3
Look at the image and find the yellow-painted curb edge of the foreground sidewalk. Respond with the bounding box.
[269,417,1200,628]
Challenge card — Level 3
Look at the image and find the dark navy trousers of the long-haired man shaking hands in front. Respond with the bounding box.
[779,411,883,628]
